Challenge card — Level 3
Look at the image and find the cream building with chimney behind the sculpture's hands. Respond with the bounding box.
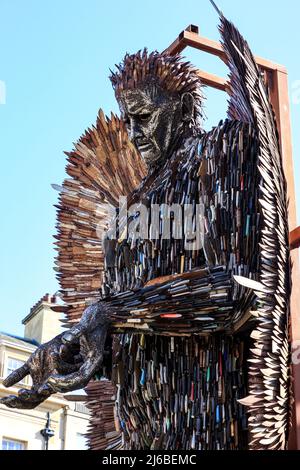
[0,294,89,450]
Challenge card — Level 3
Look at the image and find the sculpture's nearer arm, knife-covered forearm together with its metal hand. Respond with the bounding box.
[34,268,234,393]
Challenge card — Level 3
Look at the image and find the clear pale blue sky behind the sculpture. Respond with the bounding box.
[0,0,300,334]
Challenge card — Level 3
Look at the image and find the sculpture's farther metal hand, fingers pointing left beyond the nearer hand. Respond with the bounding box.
[0,334,82,409]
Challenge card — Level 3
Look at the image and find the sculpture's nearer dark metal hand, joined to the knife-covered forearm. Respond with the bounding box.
[39,302,111,393]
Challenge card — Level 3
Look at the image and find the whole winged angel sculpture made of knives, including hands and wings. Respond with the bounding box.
[1,4,291,450]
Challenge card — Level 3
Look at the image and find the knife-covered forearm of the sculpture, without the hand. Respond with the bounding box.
[75,267,233,335]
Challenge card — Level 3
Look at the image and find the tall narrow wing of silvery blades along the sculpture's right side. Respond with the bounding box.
[220,14,291,450]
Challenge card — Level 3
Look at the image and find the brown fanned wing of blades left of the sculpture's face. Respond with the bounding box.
[55,110,145,326]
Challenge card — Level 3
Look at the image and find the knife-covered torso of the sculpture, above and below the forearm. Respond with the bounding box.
[105,121,259,449]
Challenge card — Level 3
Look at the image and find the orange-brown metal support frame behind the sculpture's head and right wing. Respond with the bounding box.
[166,25,300,450]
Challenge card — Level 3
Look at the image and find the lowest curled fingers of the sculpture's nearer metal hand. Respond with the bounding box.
[46,354,103,393]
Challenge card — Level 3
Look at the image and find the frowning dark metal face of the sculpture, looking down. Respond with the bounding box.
[119,87,182,167]
